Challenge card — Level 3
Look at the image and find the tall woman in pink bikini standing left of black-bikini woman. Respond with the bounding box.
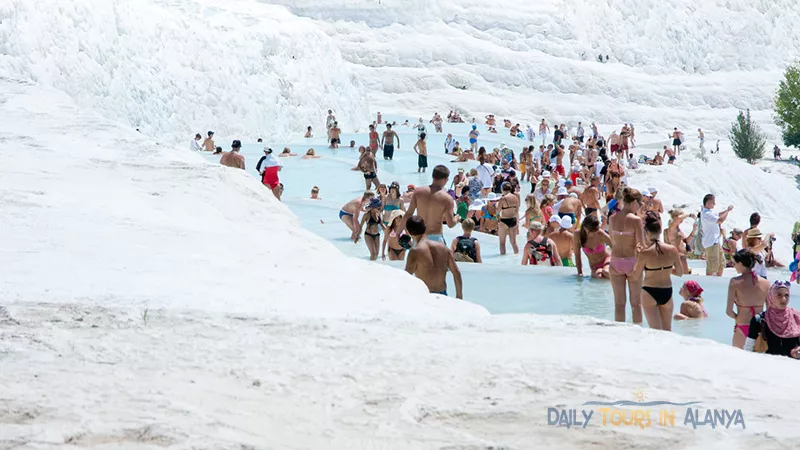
[608,188,645,324]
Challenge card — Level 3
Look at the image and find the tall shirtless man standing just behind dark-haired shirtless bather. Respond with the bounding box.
[403,165,461,247]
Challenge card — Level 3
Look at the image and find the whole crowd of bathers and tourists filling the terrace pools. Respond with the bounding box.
[198,111,800,356]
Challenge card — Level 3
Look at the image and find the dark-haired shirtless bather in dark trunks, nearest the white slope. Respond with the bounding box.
[405,214,463,299]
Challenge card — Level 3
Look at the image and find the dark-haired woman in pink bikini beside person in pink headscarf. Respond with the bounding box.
[725,250,769,348]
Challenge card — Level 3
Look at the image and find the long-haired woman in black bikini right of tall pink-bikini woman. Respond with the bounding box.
[633,211,683,331]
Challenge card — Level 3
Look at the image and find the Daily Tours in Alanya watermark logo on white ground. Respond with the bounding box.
[547,389,747,430]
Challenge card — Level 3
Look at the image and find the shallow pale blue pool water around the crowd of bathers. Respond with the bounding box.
[207,117,785,344]
